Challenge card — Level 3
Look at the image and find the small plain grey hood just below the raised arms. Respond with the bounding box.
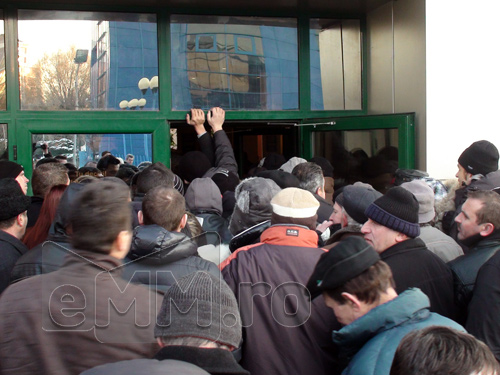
[184,177,222,215]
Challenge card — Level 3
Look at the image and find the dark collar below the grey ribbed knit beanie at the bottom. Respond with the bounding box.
[155,346,250,375]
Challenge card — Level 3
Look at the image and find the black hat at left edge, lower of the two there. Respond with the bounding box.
[0,178,31,221]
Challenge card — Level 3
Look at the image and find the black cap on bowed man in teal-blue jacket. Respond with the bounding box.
[307,236,380,299]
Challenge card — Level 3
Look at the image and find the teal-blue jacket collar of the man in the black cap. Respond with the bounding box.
[332,288,430,358]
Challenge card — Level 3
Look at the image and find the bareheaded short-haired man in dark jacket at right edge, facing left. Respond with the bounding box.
[448,190,500,323]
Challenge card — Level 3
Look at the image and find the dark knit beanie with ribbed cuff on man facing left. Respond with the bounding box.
[365,186,420,238]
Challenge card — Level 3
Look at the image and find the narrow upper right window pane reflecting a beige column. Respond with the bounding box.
[309,19,362,110]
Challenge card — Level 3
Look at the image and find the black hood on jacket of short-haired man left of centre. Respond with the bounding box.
[127,225,198,263]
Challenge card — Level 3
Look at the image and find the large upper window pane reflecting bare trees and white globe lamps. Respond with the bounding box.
[18,10,158,110]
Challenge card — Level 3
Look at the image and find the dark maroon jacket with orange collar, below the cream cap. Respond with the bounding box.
[219,225,340,375]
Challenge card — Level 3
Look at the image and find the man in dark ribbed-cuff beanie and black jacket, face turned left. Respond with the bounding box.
[361,186,457,319]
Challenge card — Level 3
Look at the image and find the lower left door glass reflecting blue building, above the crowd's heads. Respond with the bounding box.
[32,134,153,168]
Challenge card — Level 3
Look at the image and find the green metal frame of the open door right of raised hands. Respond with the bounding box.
[300,113,415,169]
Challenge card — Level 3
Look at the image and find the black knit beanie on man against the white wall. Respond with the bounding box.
[458,141,498,176]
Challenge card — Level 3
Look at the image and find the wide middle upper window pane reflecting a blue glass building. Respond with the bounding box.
[170,15,299,110]
